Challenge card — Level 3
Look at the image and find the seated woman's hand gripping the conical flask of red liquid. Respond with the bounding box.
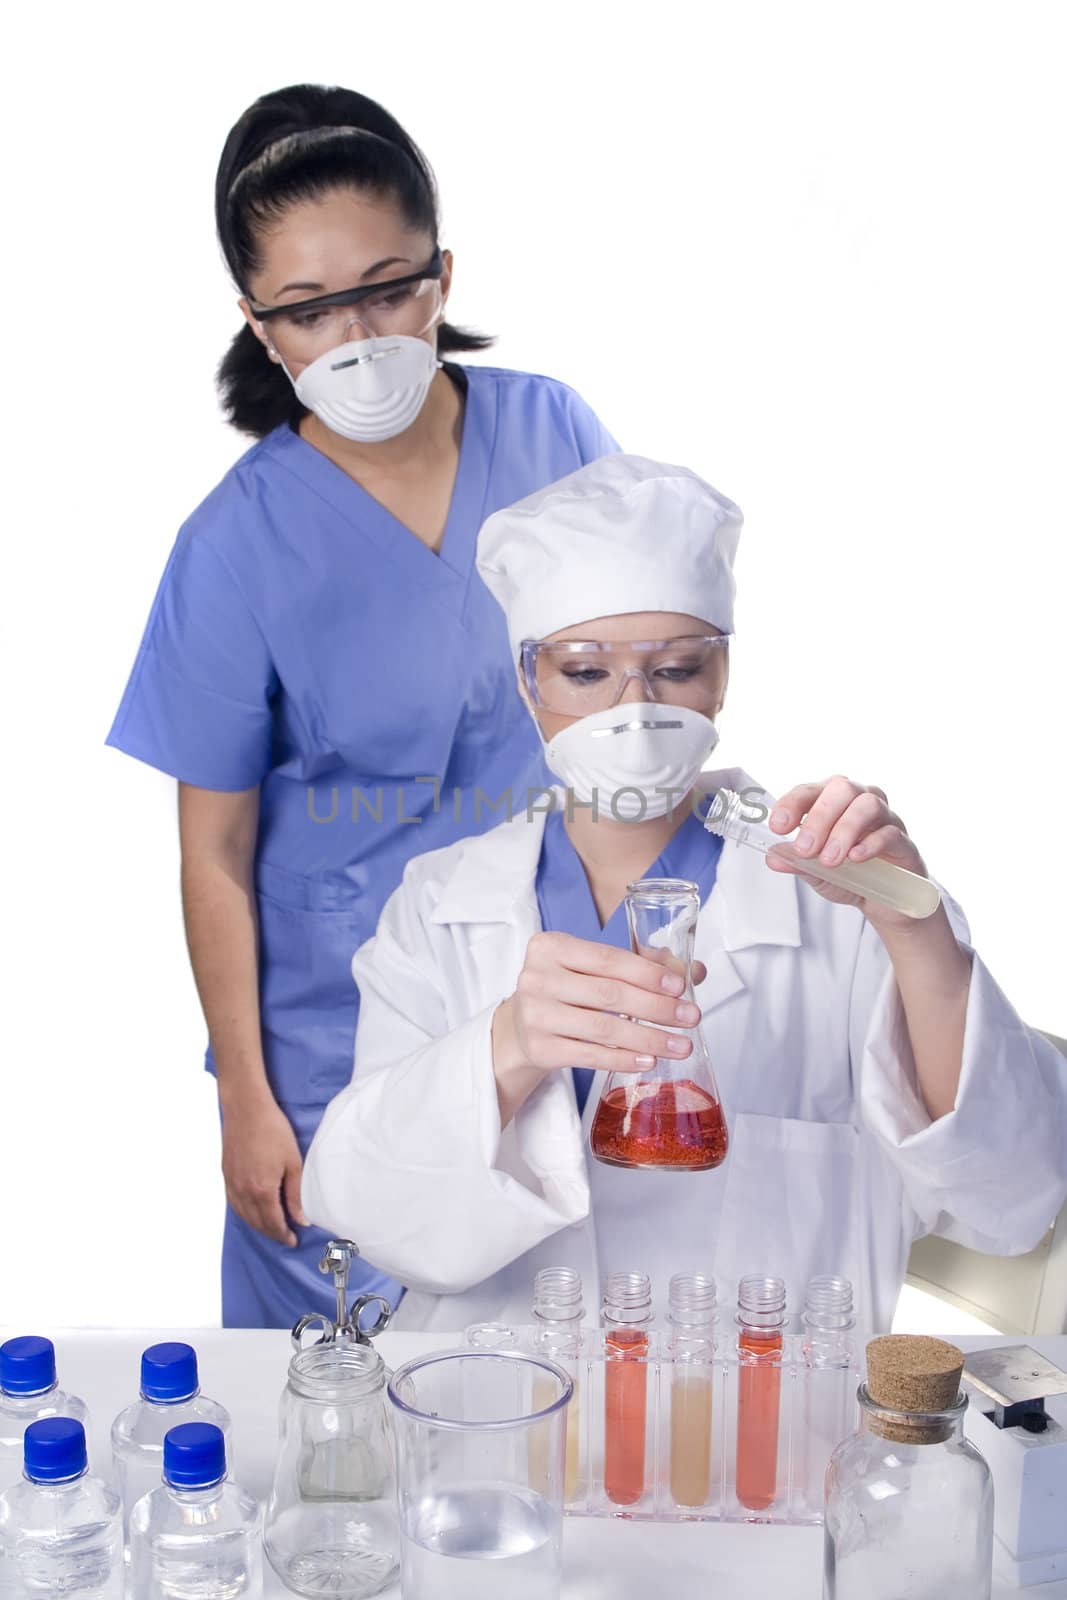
[493,933,705,1122]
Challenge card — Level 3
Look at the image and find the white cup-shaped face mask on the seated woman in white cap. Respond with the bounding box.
[544,702,718,822]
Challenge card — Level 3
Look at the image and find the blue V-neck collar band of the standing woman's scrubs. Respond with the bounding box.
[264,366,498,605]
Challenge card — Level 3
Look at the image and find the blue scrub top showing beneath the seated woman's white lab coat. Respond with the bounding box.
[537,812,723,1115]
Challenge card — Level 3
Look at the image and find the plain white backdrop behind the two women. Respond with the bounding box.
[0,0,1067,1331]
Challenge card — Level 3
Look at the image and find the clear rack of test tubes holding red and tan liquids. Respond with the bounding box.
[515,1328,864,1525]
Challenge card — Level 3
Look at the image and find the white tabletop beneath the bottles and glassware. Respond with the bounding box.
[0,1326,1067,1600]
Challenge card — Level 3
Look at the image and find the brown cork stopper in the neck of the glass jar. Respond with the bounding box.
[867,1333,963,1445]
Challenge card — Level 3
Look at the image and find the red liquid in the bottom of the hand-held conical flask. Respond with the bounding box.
[589,1078,726,1173]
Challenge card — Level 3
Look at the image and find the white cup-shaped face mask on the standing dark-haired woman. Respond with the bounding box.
[282,333,440,445]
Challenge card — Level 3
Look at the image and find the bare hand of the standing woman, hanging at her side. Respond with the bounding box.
[222,1094,307,1246]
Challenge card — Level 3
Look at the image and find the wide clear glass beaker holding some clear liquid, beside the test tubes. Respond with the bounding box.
[389,1349,573,1600]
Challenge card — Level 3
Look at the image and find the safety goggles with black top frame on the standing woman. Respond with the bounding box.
[251,246,445,363]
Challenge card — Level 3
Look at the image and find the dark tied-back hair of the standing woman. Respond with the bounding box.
[214,83,493,438]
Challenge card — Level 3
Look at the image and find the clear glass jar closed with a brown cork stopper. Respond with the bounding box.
[822,1334,993,1600]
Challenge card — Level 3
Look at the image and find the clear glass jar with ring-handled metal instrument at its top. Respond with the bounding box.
[264,1238,400,1600]
